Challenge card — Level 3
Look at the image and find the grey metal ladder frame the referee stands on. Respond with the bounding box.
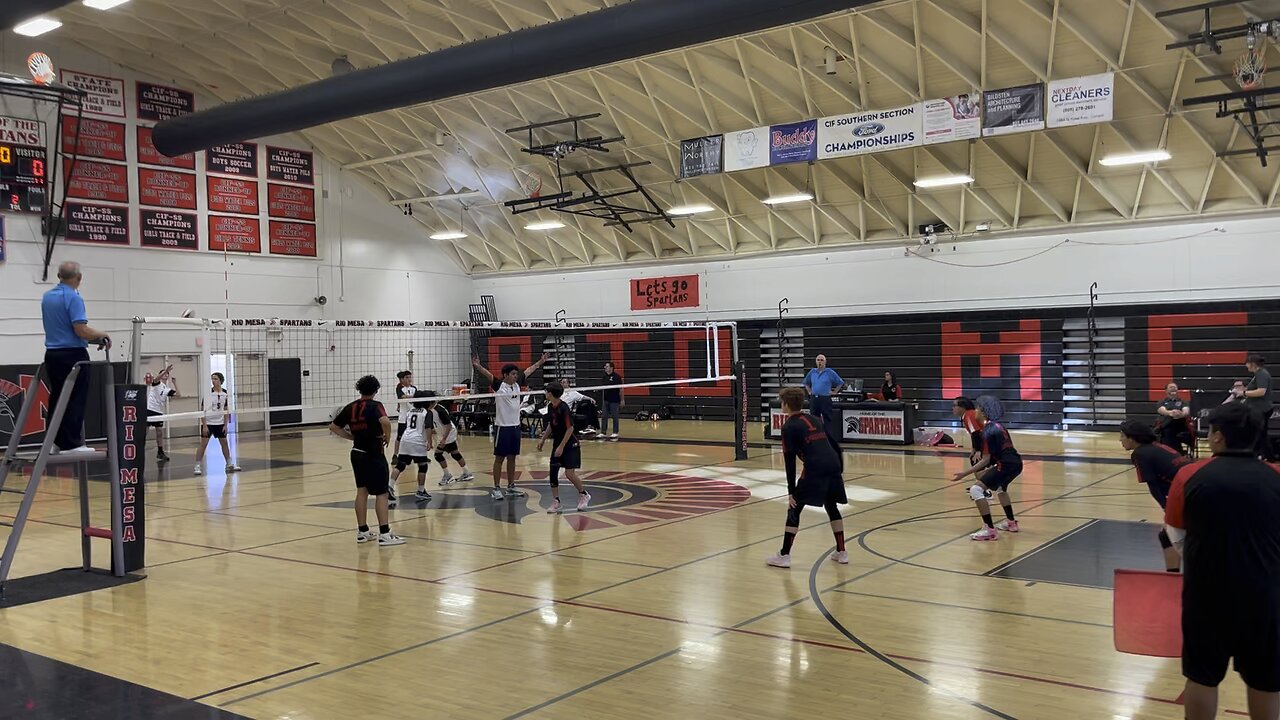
[0,360,124,598]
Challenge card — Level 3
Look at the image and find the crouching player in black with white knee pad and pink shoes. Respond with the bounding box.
[951,395,1023,541]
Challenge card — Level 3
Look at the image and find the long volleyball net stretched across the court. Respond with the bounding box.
[128,318,746,455]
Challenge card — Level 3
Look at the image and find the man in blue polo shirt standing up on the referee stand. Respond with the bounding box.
[40,261,111,452]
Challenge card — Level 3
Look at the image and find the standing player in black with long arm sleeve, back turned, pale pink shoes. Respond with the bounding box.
[764,387,849,568]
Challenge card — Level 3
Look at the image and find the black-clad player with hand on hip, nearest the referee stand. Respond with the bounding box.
[329,375,404,547]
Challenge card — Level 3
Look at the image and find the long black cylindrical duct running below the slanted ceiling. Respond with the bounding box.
[152,0,877,156]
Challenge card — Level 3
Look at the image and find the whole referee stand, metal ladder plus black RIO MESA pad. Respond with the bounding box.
[0,360,146,605]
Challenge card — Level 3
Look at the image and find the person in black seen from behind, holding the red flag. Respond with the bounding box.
[1165,402,1280,720]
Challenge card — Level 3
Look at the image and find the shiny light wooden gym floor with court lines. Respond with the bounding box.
[0,421,1244,720]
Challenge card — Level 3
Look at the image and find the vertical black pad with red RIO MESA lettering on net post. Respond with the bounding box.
[111,386,147,573]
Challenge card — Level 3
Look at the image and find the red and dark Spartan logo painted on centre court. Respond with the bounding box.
[311,470,751,530]
